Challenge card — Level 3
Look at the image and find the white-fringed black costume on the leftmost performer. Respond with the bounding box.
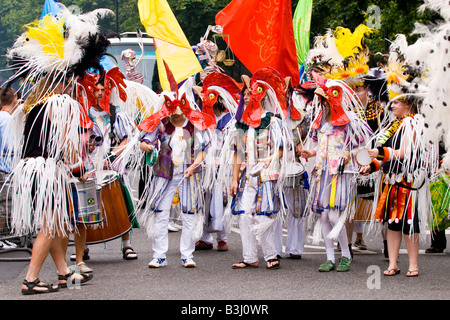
[4,94,81,236]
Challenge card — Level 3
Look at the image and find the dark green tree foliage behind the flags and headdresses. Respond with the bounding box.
[0,0,438,82]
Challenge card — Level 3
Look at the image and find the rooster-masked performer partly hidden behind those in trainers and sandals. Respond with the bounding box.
[194,72,242,251]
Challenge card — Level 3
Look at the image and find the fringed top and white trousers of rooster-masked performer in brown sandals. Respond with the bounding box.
[231,113,283,263]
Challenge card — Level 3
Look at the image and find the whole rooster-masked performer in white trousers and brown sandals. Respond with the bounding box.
[230,68,295,269]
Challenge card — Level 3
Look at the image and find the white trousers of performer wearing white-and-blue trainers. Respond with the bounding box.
[153,174,195,259]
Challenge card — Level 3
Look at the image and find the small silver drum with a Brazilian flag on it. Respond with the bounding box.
[72,178,103,224]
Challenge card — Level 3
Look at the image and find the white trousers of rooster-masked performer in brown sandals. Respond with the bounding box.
[238,177,277,263]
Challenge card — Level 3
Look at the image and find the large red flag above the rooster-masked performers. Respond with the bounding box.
[216,0,300,85]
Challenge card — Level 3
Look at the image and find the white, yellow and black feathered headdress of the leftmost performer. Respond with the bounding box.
[7,5,113,99]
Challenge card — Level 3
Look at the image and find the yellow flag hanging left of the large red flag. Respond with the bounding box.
[138,0,203,91]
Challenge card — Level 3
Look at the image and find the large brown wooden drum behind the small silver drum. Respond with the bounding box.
[86,171,131,244]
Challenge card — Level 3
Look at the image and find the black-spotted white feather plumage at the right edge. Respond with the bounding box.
[404,0,450,172]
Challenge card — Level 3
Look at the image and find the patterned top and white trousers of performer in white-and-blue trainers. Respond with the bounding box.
[139,118,210,259]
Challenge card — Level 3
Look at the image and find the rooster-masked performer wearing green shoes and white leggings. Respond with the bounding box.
[301,72,372,272]
